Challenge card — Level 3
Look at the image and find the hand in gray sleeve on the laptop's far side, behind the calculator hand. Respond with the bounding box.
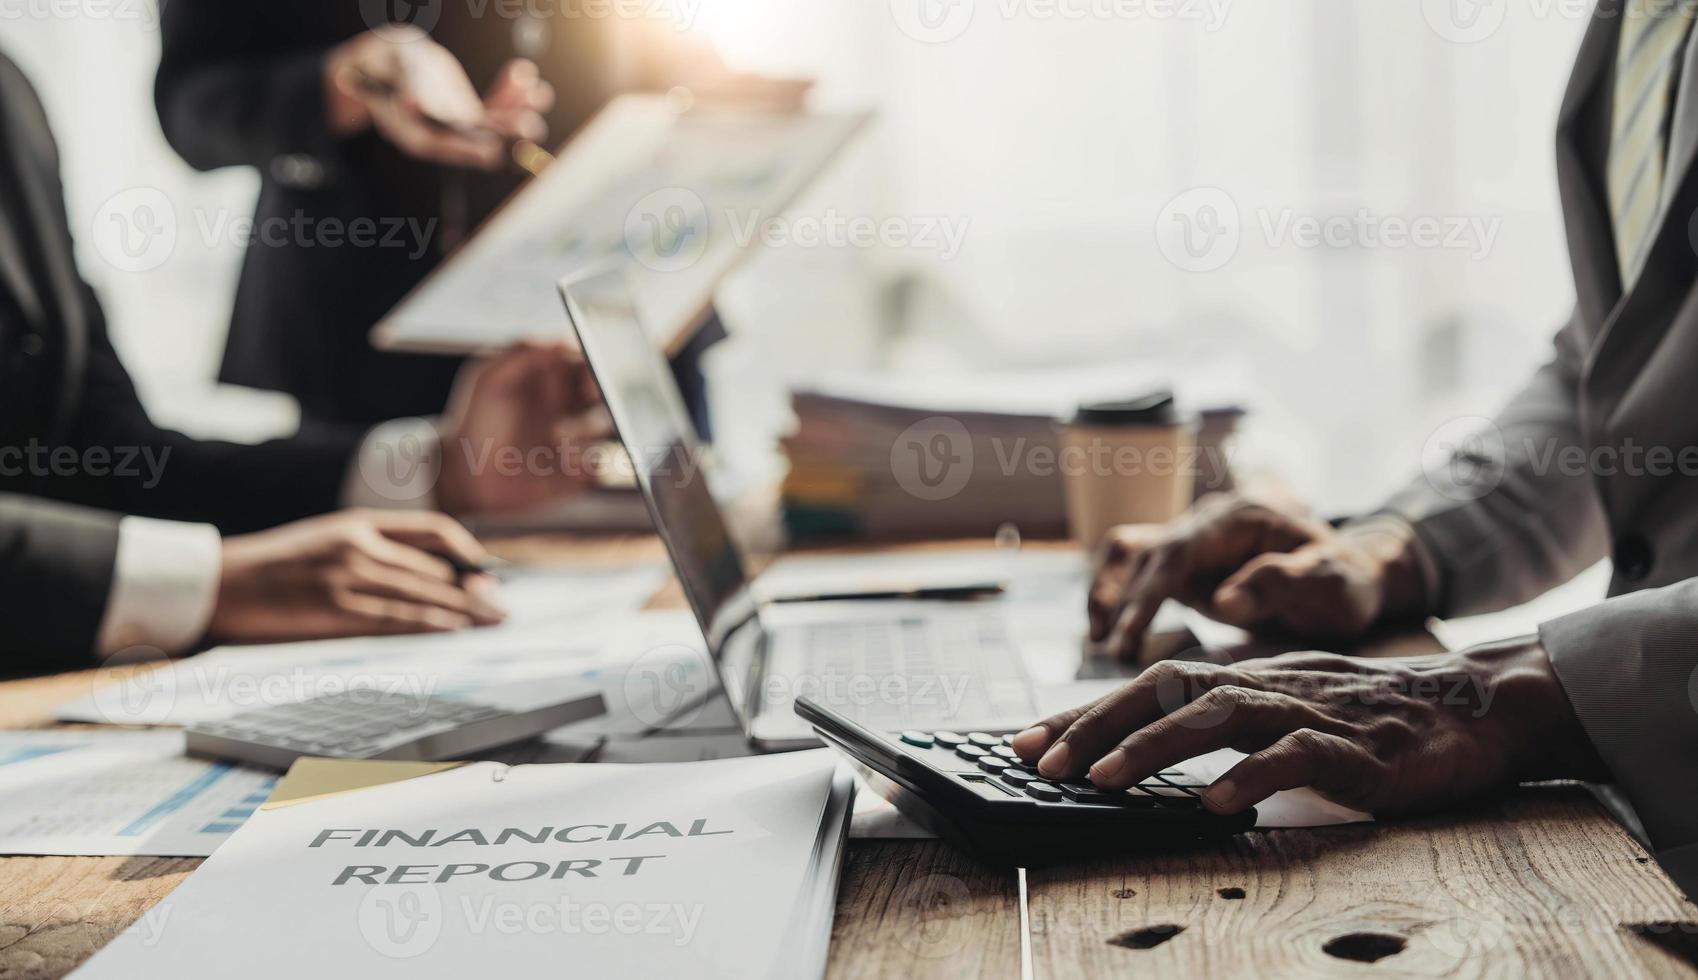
[1088,496,1425,659]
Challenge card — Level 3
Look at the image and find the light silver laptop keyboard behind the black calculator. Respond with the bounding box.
[776,613,1037,730]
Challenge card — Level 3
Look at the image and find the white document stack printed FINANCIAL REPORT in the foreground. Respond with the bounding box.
[76,752,849,980]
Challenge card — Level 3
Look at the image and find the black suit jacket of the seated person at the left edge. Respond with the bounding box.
[0,56,360,662]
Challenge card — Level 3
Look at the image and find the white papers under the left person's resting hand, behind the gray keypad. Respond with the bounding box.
[56,566,664,725]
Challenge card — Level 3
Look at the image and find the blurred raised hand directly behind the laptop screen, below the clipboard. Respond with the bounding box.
[436,343,613,515]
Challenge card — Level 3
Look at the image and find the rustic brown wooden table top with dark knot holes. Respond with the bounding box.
[0,538,1698,980]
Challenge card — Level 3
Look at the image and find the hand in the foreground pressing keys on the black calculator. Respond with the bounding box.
[1014,640,1605,814]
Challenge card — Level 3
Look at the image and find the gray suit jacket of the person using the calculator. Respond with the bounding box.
[1386,0,1698,893]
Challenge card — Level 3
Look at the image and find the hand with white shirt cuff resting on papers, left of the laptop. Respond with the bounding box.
[207,511,506,644]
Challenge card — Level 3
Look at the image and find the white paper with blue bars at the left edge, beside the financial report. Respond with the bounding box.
[0,729,277,858]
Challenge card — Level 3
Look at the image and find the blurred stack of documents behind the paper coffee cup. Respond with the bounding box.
[783,360,1241,540]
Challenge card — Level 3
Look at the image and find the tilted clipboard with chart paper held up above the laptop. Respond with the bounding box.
[372,95,871,355]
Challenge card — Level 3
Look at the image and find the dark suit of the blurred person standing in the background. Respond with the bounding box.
[155,0,613,425]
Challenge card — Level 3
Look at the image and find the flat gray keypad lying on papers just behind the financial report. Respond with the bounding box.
[195,690,508,759]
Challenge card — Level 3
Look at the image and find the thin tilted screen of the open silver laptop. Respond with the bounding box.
[560,267,759,712]
